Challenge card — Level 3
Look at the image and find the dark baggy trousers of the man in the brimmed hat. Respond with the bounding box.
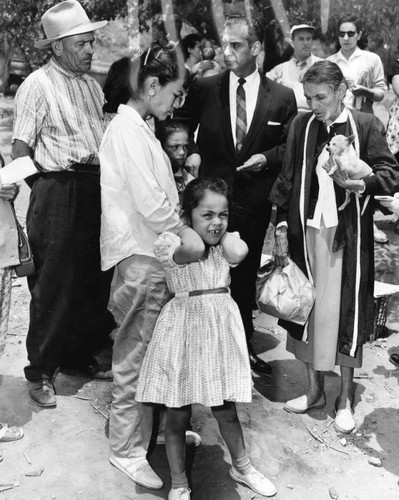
[25,172,114,381]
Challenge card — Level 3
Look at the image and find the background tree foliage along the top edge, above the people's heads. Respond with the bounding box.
[0,0,399,83]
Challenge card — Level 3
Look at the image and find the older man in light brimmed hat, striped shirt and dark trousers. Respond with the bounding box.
[12,0,114,408]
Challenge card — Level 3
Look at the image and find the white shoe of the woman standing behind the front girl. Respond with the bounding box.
[109,456,163,490]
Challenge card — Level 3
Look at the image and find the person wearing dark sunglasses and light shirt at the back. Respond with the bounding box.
[328,15,386,113]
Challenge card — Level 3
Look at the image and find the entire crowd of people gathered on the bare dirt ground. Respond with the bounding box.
[0,0,399,500]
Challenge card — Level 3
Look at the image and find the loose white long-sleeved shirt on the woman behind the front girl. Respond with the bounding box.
[99,104,182,271]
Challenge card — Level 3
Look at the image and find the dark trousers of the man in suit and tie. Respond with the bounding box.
[229,205,271,348]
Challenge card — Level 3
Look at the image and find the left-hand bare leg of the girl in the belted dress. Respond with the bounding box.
[165,406,191,489]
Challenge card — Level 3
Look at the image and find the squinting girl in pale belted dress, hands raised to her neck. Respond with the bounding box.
[136,178,276,500]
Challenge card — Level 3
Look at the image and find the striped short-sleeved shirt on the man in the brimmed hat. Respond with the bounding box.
[12,58,107,171]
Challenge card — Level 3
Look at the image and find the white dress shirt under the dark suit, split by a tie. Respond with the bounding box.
[229,67,260,146]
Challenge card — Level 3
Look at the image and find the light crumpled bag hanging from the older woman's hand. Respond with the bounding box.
[256,259,315,325]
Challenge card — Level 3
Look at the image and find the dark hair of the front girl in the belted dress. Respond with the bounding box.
[181,177,231,222]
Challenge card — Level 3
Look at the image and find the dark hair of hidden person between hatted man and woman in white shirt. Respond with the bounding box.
[103,57,131,113]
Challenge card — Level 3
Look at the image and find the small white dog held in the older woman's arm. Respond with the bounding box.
[323,135,373,210]
